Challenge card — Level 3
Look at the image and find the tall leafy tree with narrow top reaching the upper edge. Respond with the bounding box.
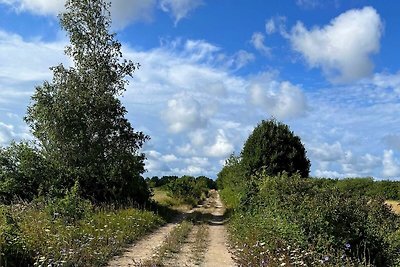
[25,0,149,202]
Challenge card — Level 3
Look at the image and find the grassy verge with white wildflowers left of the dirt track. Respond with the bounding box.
[0,205,164,266]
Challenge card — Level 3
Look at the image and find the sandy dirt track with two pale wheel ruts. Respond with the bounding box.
[108,191,236,267]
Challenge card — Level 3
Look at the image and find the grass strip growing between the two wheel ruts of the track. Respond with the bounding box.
[141,220,193,266]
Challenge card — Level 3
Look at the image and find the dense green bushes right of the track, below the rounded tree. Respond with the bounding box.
[225,173,400,266]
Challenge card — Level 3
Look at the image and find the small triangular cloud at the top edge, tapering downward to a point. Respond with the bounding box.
[160,0,203,25]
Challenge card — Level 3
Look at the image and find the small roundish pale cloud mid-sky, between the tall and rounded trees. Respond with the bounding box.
[162,94,207,133]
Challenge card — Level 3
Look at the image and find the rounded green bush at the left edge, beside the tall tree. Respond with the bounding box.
[0,143,52,203]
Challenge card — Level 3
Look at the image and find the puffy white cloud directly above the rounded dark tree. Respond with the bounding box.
[249,77,307,119]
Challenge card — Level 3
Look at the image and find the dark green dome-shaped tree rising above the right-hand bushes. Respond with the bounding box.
[241,120,310,177]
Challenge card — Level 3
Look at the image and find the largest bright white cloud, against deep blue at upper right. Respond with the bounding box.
[287,7,383,83]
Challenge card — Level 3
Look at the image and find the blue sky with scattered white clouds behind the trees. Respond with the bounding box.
[0,0,400,180]
